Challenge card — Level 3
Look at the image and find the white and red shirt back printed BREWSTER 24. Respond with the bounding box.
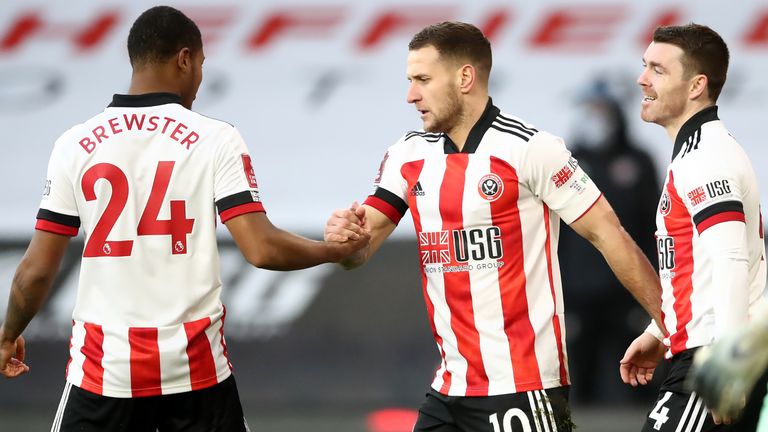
[36,93,264,397]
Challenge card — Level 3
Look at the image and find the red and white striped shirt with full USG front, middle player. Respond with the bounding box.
[365,100,600,396]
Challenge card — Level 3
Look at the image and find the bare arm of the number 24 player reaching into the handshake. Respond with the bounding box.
[225,212,370,270]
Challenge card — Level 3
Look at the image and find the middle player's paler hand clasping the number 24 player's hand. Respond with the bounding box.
[325,203,397,270]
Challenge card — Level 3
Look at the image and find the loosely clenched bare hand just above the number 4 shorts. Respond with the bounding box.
[619,332,666,387]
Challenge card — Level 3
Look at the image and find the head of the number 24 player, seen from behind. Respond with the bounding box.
[128,6,205,108]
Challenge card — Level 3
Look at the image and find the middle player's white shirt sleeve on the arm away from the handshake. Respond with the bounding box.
[521,132,601,224]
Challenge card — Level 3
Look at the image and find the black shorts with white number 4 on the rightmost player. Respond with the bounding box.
[643,348,765,432]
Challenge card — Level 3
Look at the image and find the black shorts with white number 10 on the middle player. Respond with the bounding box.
[413,387,573,432]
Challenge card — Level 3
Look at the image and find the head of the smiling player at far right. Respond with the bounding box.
[638,23,729,126]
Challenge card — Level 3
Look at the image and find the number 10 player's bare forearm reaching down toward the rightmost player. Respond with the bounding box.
[595,227,664,330]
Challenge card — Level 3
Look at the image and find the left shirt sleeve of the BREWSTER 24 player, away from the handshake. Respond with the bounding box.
[35,136,80,236]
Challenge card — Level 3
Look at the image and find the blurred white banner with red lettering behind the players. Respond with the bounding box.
[0,0,768,238]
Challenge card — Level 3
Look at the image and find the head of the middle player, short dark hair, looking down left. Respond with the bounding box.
[407,22,492,132]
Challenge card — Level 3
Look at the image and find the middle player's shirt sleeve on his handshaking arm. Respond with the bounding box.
[363,138,408,225]
